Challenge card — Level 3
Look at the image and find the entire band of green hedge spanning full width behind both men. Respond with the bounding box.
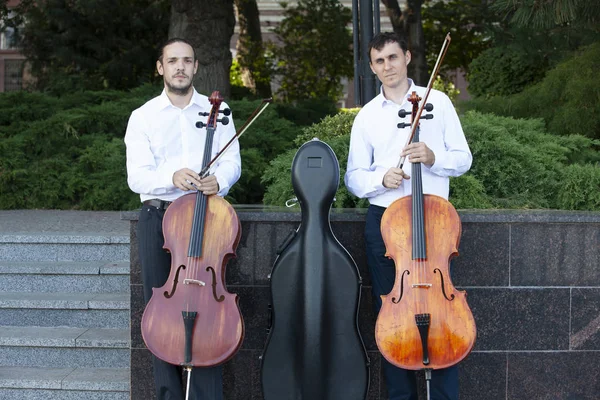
[0,86,600,210]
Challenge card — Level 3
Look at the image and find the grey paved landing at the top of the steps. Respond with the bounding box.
[0,210,129,236]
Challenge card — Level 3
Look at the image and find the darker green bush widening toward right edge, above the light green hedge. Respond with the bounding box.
[461,42,600,139]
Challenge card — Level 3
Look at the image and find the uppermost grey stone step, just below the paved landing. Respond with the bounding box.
[0,234,129,262]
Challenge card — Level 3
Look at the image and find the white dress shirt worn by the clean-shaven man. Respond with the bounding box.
[344,79,472,207]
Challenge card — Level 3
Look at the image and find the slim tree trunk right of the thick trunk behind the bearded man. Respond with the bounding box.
[235,0,271,97]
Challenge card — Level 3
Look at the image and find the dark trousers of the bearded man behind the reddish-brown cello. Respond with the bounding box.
[137,206,223,400]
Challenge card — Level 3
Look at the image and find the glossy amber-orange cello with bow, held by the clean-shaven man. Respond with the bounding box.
[375,35,476,394]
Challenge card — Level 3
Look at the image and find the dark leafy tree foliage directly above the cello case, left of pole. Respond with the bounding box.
[269,0,353,102]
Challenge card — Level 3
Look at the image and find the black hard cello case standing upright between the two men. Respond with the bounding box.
[261,139,369,400]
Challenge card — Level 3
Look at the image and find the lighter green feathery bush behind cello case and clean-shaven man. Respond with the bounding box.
[263,110,600,210]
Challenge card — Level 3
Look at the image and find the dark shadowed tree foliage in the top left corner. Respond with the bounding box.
[4,0,169,92]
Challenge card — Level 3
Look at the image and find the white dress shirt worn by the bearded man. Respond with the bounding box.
[125,89,241,202]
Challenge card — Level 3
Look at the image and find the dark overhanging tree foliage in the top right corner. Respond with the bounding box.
[468,0,600,97]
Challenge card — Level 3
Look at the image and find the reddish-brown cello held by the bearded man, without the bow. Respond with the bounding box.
[142,92,244,394]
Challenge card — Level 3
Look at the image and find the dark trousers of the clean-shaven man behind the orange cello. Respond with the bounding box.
[365,205,458,400]
